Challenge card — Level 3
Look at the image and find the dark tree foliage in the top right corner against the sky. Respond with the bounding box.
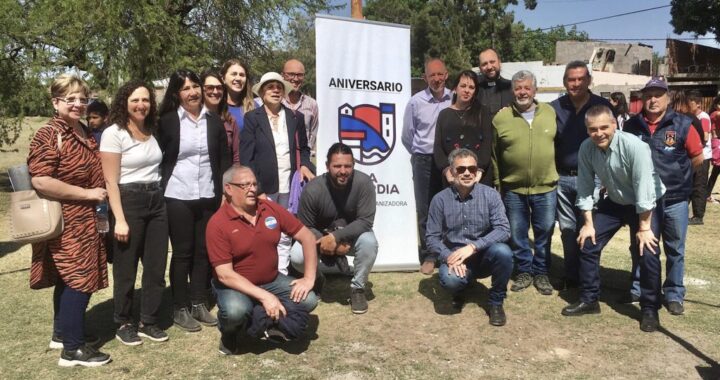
[670,0,720,42]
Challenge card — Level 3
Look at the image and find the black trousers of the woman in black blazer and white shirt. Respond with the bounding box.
[165,198,217,309]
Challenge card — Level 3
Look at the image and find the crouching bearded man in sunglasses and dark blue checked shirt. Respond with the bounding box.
[426,148,513,326]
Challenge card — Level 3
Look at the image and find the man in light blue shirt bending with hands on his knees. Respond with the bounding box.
[562,105,665,332]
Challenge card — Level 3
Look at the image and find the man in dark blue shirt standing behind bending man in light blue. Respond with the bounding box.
[550,61,612,288]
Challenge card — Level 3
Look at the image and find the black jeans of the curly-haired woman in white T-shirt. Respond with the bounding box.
[113,184,168,325]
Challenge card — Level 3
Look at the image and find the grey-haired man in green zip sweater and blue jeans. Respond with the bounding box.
[492,70,558,295]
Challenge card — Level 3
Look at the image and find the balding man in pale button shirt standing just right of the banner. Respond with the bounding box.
[402,58,452,275]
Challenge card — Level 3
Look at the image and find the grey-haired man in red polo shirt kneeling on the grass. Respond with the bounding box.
[206,164,318,355]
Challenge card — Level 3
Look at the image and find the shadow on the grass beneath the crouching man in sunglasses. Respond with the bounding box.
[418,273,488,315]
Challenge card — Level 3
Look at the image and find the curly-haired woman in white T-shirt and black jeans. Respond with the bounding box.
[100,81,168,346]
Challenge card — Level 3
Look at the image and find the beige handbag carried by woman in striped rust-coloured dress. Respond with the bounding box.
[9,133,64,244]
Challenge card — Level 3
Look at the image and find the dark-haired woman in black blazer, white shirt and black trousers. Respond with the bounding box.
[158,70,231,332]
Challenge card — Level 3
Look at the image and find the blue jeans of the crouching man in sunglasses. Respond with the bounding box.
[439,243,513,305]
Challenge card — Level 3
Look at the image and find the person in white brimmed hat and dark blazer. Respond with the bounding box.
[240,72,315,202]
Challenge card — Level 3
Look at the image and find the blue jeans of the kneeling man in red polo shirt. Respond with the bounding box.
[211,273,318,334]
